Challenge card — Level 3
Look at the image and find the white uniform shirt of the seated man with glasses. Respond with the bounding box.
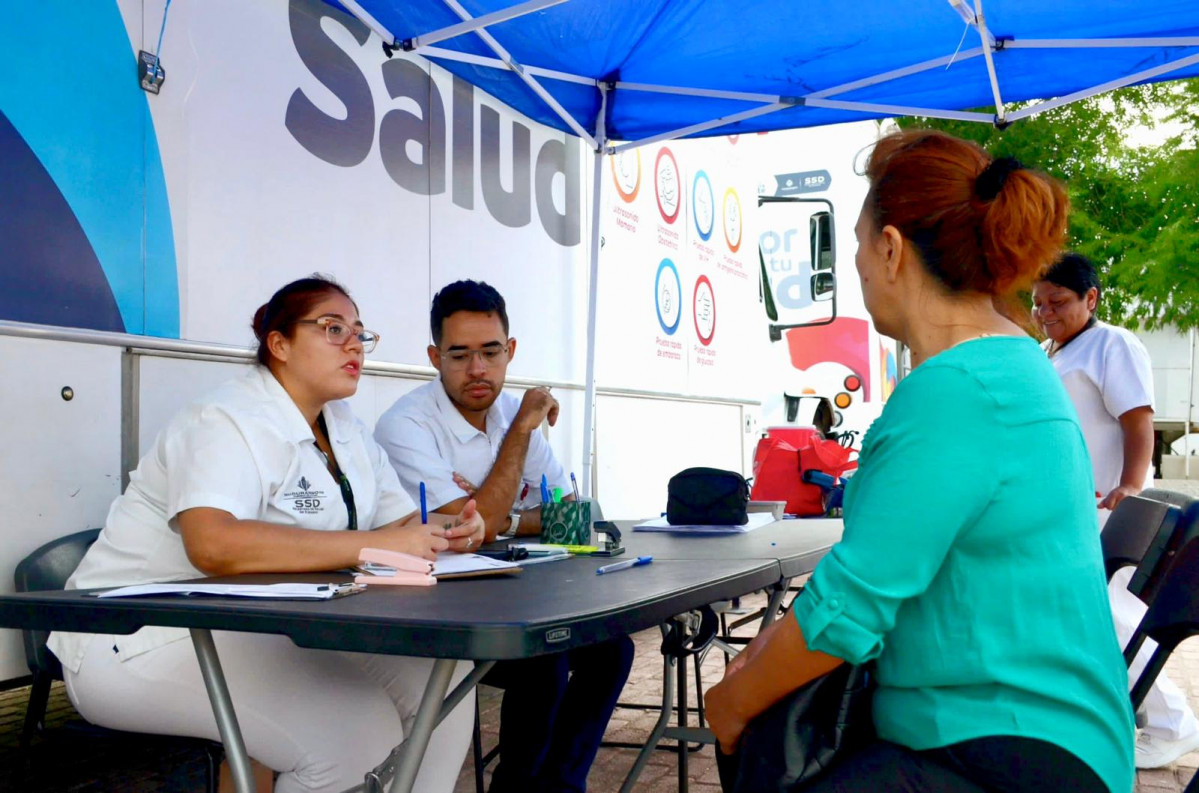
[375,379,571,511]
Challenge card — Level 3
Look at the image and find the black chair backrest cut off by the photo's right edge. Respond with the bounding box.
[1125,499,1199,708]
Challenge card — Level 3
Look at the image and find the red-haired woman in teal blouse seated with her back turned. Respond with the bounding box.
[706,131,1134,793]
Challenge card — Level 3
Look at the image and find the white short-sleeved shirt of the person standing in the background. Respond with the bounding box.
[1044,323,1153,497]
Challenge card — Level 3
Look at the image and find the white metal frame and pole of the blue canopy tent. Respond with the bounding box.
[341,0,1199,495]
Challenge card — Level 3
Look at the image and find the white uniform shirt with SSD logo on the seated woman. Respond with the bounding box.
[49,366,415,672]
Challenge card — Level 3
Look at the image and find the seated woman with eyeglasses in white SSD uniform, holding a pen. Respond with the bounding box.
[49,276,483,793]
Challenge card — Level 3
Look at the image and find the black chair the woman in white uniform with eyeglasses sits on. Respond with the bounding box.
[13,529,224,793]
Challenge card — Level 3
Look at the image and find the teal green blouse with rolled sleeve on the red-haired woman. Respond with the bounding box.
[794,336,1134,793]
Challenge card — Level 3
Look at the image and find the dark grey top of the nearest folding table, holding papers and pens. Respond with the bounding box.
[0,557,778,660]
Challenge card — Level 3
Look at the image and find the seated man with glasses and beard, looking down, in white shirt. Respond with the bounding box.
[375,281,633,793]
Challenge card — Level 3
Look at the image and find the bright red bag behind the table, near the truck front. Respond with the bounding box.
[749,431,857,516]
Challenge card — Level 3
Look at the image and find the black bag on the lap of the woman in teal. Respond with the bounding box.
[716,663,874,793]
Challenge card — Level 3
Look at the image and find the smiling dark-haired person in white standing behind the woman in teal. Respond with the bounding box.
[1032,253,1199,768]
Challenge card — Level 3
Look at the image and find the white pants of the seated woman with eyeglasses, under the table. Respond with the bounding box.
[66,631,474,793]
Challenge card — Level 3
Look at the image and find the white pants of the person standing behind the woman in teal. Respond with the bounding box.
[1108,567,1199,740]
